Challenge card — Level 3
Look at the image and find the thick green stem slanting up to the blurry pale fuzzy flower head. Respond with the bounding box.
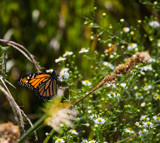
[17,114,47,143]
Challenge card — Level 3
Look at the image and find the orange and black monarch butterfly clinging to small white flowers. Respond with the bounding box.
[18,70,58,100]
